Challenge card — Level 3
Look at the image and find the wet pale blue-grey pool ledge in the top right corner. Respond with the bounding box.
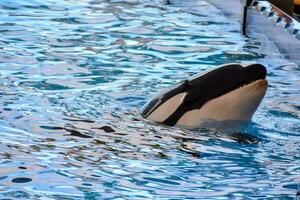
[207,0,300,66]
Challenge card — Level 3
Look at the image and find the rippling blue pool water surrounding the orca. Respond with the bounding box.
[0,0,300,199]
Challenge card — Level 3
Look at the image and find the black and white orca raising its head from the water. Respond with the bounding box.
[140,63,268,127]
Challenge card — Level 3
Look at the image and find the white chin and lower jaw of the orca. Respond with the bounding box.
[176,80,268,127]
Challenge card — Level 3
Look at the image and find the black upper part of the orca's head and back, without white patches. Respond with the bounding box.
[141,64,267,122]
